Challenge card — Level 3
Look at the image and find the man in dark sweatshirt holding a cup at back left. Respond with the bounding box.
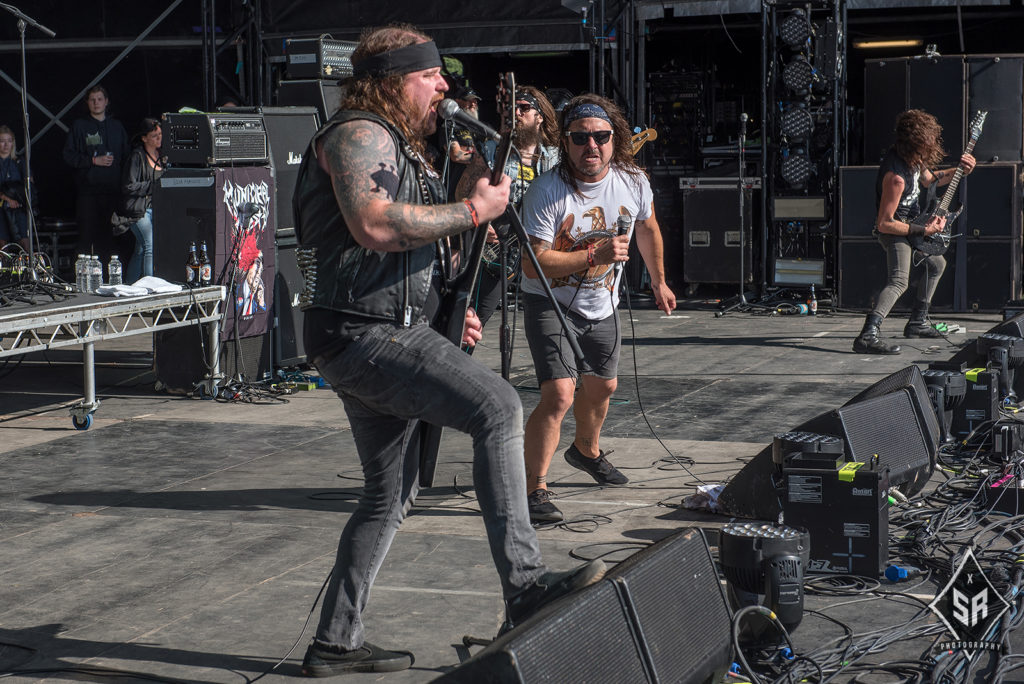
[63,85,130,262]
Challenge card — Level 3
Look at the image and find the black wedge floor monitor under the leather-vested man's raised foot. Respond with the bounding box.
[434,528,732,684]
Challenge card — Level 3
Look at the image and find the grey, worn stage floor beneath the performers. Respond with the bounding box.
[0,301,1000,683]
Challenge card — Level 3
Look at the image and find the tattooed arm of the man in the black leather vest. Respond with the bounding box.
[319,120,473,252]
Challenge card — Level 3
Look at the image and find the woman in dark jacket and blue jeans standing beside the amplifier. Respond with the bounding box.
[119,118,164,284]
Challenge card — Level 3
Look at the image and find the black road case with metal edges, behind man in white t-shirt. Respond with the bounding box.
[682,187,754,284]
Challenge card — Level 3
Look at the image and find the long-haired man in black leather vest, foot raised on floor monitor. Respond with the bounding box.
[294,26,604,677]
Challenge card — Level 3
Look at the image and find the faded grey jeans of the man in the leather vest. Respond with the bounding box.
[313,325,547,649]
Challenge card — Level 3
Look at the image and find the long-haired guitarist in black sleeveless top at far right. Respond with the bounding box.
[853,110,975,354]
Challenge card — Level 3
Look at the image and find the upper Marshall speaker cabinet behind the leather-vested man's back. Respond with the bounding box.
[262,106,319,234]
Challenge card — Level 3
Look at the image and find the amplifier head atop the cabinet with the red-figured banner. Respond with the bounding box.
[160,112,269,166]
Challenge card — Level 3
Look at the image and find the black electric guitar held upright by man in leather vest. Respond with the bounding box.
[418,72,515,487]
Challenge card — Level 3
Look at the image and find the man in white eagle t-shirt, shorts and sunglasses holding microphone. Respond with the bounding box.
[522,94,676,523]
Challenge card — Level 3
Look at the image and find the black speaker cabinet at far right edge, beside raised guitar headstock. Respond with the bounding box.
[967,55,1024,162]
